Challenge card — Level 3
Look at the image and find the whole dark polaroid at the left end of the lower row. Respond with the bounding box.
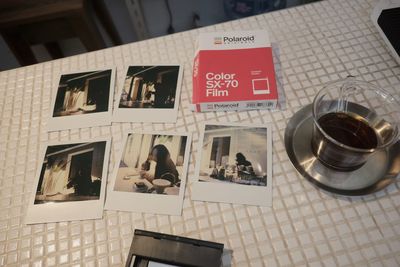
[25,138,110,224]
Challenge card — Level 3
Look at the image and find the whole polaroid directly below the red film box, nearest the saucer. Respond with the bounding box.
[192,123,272,206]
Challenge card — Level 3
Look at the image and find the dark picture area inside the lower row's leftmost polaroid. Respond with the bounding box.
[35,141,106,204]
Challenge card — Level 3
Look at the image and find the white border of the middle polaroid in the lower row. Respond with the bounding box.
[104,131,192,215]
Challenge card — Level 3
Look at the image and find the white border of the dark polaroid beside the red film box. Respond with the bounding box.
[112,63,184,123]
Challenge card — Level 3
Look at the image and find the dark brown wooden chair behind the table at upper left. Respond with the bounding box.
[0,0,122,66]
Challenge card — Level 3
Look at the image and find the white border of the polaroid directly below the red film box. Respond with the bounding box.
[192,121,272,206]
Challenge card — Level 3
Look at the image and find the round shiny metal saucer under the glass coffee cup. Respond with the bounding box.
[285,105,400,196]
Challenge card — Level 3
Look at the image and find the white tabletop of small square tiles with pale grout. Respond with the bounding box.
[0,0,400,266]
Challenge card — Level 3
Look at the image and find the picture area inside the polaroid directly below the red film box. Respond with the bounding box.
[199,125,268,186]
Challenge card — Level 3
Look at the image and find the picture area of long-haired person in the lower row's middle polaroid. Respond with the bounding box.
[114,134,187,195]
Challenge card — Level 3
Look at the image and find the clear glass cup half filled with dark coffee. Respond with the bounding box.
[311,77,400,171]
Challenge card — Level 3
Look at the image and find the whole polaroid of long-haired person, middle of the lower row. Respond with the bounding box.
[105,132,191,218]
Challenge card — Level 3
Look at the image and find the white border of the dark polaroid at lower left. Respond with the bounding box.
[25,137,111,224]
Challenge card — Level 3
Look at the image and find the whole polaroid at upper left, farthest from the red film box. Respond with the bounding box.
[47,68,115,131]
